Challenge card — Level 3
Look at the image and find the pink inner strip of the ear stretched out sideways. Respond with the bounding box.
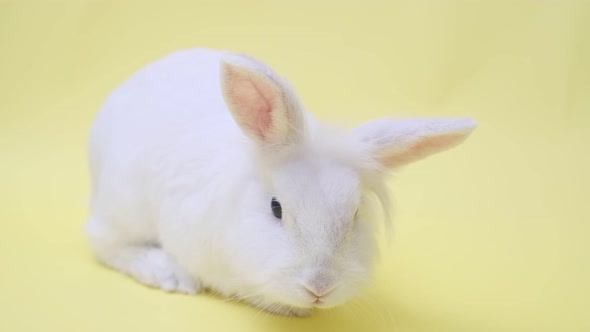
[379,133,466,167]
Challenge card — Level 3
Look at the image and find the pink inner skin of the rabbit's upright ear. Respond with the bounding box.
[226,66,276,141]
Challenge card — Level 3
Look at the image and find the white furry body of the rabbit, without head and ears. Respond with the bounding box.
[88,50,314,314]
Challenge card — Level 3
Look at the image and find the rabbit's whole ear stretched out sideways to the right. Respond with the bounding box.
[353,119,476,168]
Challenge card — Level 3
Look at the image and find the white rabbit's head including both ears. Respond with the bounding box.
[221,63,475,308]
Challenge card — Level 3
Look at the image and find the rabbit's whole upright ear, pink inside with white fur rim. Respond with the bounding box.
[221,62,303,146]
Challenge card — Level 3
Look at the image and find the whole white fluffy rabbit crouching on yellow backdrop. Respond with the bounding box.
[86,49,475,316]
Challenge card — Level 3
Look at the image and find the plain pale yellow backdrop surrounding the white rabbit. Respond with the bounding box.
[0,1,590,332]
